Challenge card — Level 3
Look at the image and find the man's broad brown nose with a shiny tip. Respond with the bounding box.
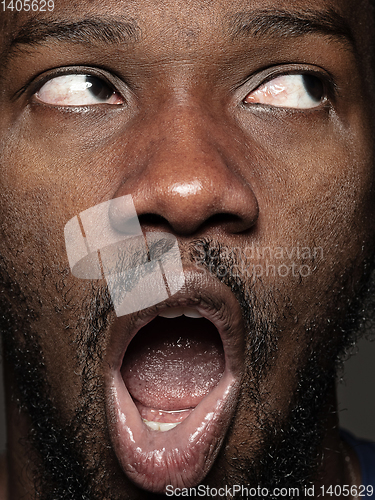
[112,105,258,236]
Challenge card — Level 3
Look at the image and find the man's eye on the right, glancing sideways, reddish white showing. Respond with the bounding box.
[244,74,326,109]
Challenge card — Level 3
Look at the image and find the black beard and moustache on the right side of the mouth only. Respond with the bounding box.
[192,240,375,499]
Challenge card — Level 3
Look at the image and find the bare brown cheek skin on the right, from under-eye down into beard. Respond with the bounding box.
[223,108,375,422]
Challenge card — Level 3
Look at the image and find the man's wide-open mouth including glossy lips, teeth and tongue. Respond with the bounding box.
[107,276,243,493]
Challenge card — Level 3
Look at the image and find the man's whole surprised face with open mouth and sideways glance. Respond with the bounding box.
[0,0,375,499]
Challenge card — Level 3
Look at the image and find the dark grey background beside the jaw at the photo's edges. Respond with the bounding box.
[0,340,375,452]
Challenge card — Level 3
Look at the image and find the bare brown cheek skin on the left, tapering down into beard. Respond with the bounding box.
[0,132,108,421]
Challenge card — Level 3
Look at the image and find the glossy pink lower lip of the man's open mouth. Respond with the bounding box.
[108,328,239,493]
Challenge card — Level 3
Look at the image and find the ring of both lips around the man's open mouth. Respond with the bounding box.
[106,271,244,492]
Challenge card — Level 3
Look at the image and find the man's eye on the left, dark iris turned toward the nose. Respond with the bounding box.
[35,74,125,106]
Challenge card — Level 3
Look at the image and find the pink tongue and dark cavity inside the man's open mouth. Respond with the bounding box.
[121,316,224,411]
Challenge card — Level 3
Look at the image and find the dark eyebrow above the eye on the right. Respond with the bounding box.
[228,9,355,49]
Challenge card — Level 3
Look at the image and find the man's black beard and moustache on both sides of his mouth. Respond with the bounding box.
[0,240,375,500]
